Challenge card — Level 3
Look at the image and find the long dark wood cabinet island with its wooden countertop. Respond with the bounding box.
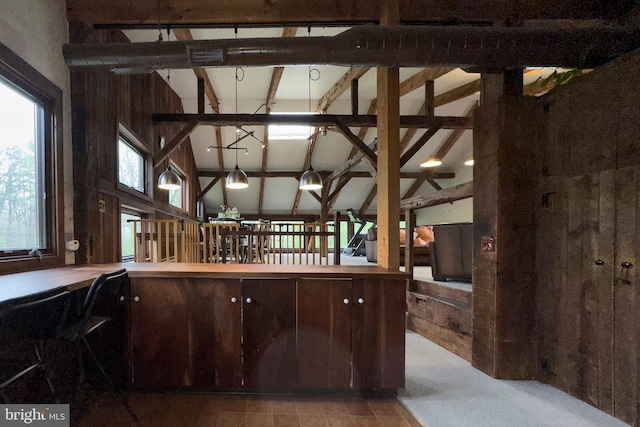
[0,263,408,393]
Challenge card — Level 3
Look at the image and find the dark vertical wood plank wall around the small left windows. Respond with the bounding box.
[70,23,199,263]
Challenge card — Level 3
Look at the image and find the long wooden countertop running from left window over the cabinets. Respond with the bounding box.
[0,263,409,302]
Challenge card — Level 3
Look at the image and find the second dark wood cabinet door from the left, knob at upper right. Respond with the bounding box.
[188,279,242,391]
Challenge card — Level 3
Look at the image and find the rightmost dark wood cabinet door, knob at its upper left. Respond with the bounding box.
[352,278,406,389]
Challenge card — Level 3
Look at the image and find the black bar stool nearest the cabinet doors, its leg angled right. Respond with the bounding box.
[60,269,138,422]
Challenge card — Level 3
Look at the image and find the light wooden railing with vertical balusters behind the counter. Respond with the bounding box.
[131,219,333,265]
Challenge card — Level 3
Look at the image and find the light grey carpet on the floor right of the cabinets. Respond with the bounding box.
[398,332,628,427]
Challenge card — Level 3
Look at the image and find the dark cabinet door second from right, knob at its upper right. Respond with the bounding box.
[297,279,352,389]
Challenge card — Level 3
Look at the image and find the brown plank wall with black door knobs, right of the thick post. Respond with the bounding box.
[536,54,640,425]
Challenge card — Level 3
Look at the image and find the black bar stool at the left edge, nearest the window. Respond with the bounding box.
[0,288,71,404]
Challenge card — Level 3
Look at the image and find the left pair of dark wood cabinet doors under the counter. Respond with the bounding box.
[131,278,242,390]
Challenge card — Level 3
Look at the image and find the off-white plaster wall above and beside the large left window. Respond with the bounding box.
[0,0,75,264]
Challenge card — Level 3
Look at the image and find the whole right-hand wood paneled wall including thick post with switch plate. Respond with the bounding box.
[473,48,640,426]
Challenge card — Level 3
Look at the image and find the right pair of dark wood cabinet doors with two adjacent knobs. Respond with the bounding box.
[297,279,406,390]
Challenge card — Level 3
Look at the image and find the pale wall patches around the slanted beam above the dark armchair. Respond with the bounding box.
[416,162,473,225]
